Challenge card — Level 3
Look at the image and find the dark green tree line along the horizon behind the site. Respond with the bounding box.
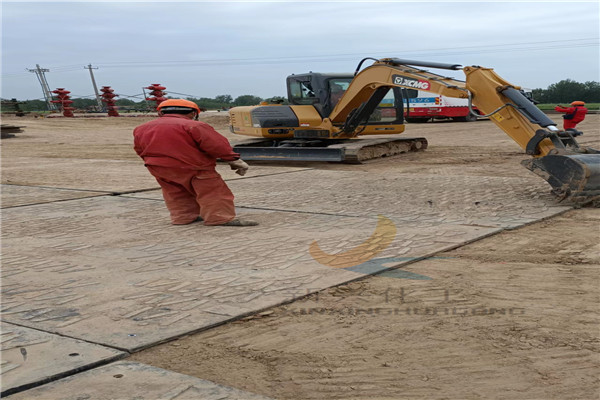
[2,79,600,112]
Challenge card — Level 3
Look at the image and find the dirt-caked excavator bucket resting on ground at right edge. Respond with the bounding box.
[521,154,600,203]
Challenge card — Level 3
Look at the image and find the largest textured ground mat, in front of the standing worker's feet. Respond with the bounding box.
[1,196,499,351]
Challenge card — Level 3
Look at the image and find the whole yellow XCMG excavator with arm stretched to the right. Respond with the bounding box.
[229,58,600,202]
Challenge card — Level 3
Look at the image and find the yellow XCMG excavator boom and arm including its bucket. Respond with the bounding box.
[330,58,600,201]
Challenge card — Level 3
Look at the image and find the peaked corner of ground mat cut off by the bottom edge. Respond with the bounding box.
[4,361,268,400]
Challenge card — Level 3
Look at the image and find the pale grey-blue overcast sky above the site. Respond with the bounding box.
[1,0,600,100]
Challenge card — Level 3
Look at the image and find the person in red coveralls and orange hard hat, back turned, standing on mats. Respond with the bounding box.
[133,99,258,226]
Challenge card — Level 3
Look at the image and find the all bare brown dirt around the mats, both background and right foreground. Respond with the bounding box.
[2,113,600,399]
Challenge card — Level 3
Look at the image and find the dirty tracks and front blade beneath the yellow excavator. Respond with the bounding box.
[233,138,427,164]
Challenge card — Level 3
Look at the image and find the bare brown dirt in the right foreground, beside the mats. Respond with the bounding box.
[132,210,600,399]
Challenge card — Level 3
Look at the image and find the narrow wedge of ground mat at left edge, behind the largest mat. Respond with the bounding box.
[0,185,106,208]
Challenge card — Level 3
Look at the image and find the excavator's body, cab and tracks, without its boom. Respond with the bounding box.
[229,72,427,163]
